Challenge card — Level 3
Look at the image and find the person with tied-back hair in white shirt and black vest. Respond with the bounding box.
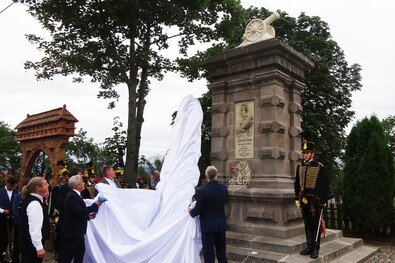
[19,177,49,263]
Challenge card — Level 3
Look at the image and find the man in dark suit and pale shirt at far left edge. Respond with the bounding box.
[0,177,19,258]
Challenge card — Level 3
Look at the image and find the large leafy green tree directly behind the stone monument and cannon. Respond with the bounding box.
[180,7,361,179]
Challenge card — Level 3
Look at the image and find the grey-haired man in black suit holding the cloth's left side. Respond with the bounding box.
[59,174,102,263]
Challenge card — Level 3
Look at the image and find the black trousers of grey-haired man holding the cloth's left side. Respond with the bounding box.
[59,237,85,263]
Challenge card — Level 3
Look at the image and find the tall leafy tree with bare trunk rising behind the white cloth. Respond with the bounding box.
[21,0,243,185]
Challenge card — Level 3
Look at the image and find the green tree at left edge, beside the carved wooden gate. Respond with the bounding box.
[0,121,21,176]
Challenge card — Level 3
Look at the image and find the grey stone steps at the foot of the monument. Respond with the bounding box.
[227,229,379,263]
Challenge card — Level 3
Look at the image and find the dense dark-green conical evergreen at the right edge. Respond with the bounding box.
[342,116,394,233]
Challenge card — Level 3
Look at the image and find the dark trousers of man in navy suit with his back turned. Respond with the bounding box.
[202,231,228,263]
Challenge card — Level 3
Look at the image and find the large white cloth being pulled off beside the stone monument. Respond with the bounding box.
[84,95,203,263]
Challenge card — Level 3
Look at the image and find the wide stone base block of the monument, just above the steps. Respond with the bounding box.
[227,186,304,238]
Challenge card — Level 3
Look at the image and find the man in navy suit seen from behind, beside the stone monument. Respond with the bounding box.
[189,166,228,263]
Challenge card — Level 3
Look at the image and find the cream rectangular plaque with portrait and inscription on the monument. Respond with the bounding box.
[235,101,254,159]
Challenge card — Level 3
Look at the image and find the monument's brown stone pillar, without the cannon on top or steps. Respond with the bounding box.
[203,38,313,238]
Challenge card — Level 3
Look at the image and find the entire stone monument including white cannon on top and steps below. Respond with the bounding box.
[203,13,377,263]
